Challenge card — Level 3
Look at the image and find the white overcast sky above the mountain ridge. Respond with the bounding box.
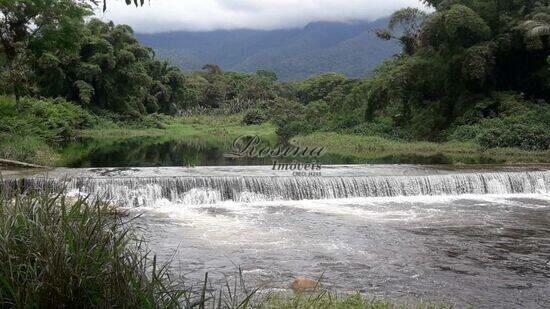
[97,0,422,32]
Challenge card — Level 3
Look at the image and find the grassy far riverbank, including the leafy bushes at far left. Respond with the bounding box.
[0,96,550,166]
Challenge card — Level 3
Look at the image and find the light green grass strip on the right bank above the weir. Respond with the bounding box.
[291,132,550,164]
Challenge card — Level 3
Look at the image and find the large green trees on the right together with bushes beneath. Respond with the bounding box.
[358,0,550,149]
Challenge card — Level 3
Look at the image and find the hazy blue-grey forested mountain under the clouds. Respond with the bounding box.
[136,19,399,80]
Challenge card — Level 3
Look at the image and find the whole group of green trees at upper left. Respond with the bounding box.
[0,0,197,118]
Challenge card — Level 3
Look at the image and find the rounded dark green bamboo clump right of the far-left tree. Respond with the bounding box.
[37,19,192,118]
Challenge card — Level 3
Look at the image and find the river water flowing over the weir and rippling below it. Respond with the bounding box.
[4,165,550,308]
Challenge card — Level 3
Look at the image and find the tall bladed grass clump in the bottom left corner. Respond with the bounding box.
[0,185,186,308]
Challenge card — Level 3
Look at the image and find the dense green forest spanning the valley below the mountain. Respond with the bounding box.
[0,0,550,155]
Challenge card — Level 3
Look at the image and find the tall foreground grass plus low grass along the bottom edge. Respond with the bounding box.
[0,184,448,309]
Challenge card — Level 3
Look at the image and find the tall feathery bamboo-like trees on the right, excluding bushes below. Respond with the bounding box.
[365,0,550,138]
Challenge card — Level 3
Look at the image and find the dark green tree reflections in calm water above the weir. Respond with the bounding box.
[62,136,500,168]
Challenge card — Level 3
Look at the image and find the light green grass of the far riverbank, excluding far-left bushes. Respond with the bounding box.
[74,115,550,165]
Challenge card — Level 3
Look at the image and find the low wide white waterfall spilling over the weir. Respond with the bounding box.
[4,171,550,207]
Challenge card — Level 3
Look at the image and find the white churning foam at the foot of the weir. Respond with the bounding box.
[129,194,550,245]
